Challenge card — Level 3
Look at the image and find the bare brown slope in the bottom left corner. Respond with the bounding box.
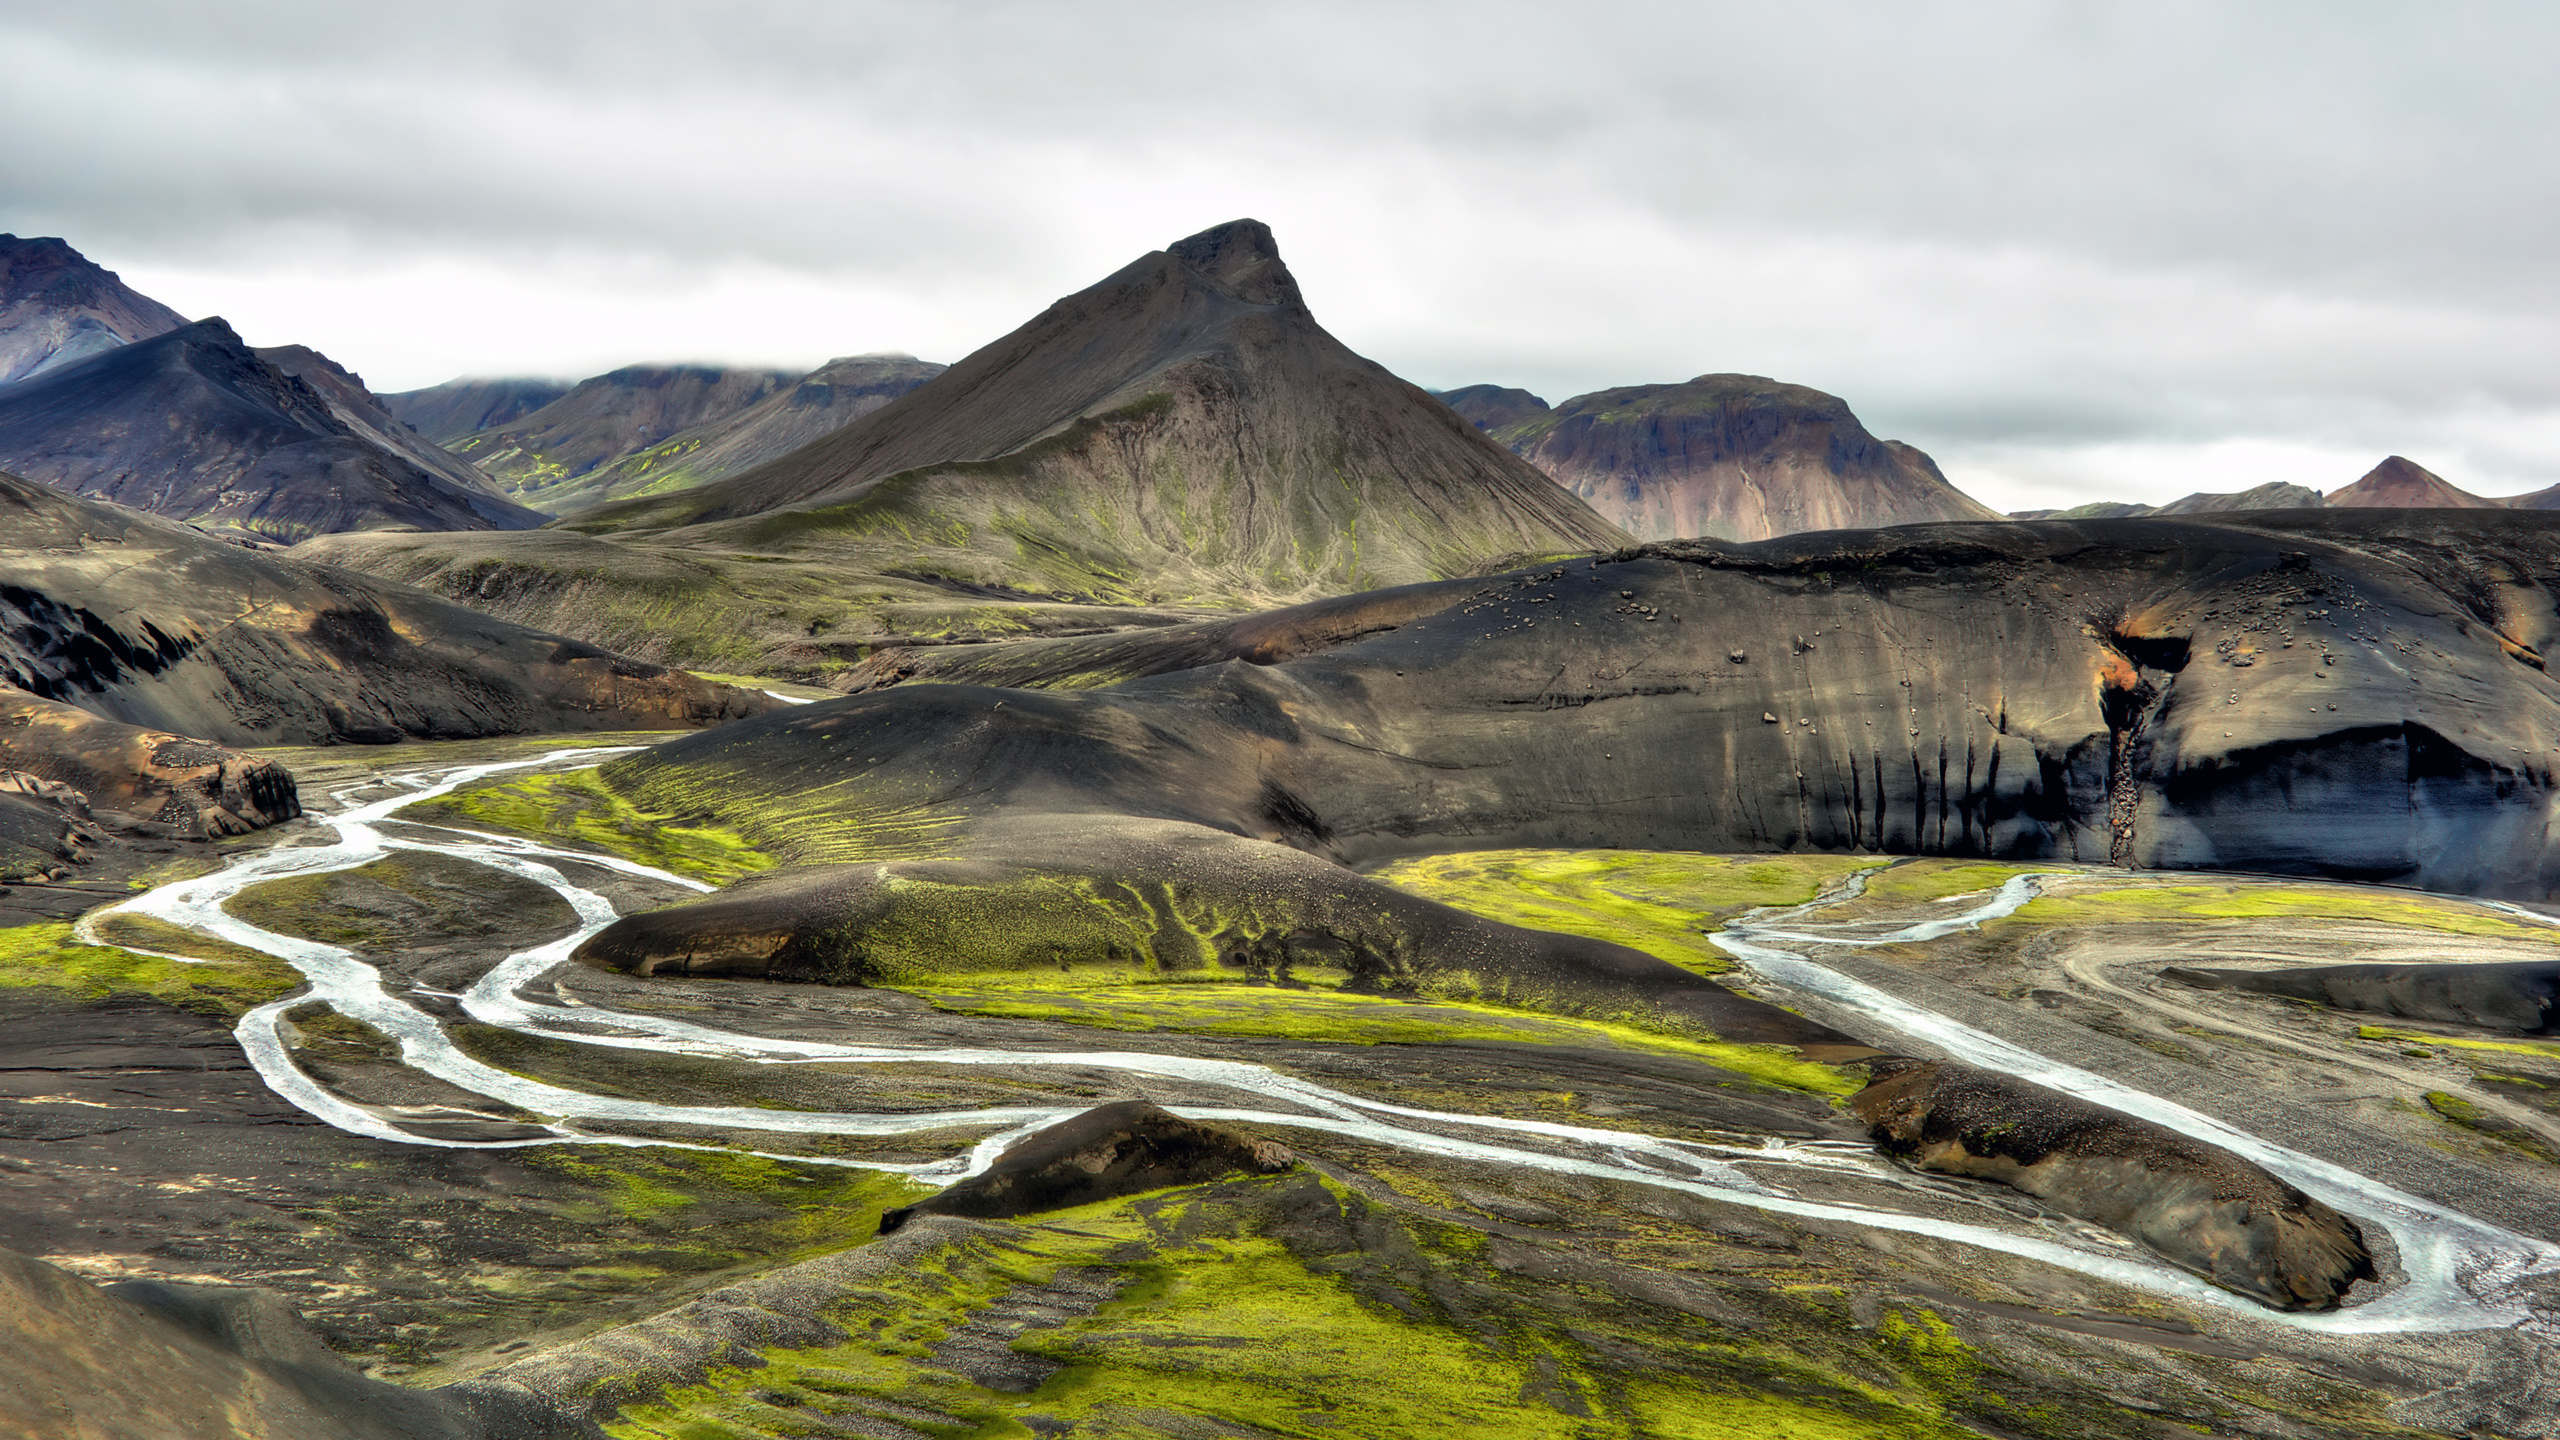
[0,1250,602,1440]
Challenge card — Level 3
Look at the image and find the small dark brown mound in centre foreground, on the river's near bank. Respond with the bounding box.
[881,1099,1295,1235]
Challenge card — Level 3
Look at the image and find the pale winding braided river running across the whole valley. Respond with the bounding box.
[82,748,2560,1335]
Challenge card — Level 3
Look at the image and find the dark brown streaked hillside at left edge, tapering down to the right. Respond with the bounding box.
[0,468,776,743]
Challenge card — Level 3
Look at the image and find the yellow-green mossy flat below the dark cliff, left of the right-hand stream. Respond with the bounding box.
[1370,851,1882,974]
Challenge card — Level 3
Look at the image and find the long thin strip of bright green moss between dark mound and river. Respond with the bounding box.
[899,974,1864,1097]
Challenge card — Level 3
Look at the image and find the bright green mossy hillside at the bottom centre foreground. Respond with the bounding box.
[607,1179,1996,1440]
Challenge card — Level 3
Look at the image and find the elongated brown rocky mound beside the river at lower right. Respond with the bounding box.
[1851,1058,2373,1309]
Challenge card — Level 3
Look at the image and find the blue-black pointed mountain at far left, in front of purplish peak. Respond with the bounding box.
[0,318,543,541]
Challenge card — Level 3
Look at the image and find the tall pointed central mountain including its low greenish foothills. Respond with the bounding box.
[294,220,1626,674]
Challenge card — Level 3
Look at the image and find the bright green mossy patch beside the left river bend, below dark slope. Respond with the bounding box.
[399,769,773,889]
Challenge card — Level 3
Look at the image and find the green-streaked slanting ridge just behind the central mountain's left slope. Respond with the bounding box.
[543,356,950,515]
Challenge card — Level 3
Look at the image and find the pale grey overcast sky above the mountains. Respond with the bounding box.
[0,0,2560,510]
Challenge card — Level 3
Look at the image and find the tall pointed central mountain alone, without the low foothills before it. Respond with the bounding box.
[579,220,1620,589]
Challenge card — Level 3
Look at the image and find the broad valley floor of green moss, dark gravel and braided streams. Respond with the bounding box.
[0,735,2560,1440]
